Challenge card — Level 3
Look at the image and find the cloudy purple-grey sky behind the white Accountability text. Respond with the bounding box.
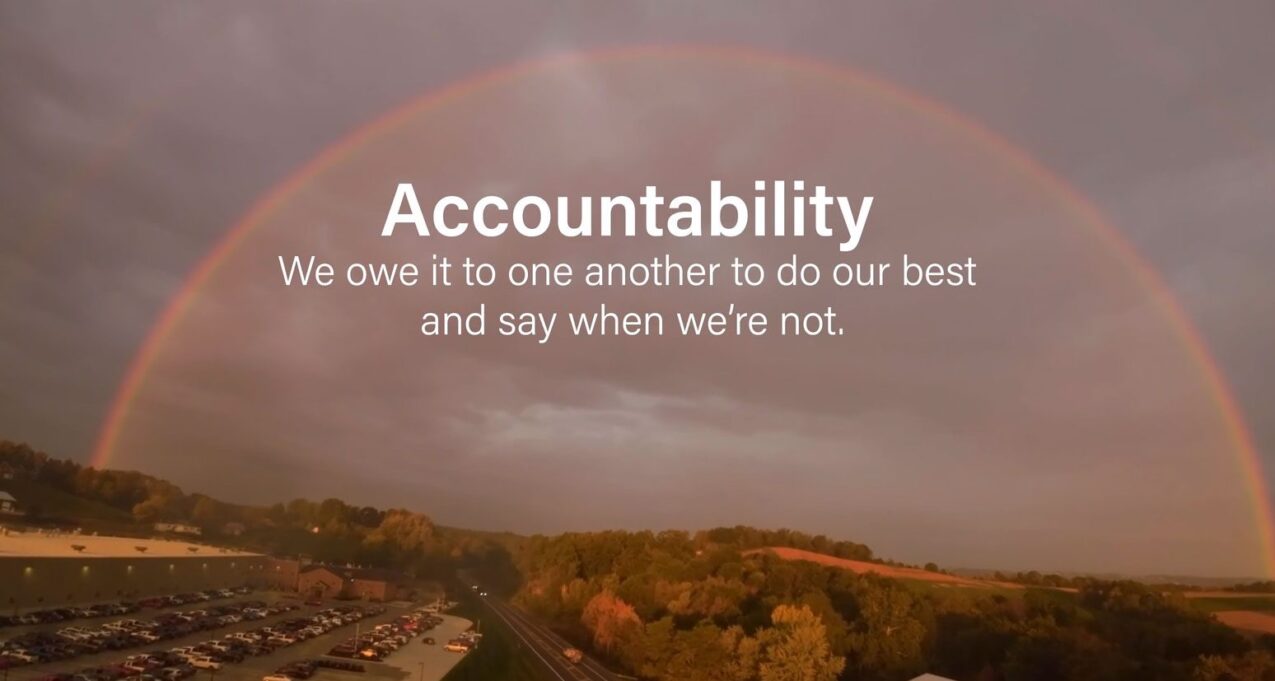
[0,3,1275,575]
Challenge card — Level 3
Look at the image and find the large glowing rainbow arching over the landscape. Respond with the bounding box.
[91,46,1275,576]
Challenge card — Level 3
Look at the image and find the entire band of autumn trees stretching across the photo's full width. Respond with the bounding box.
[0,441,1275,681]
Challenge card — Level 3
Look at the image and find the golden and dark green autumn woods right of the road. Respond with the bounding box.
[516,528,1275,681]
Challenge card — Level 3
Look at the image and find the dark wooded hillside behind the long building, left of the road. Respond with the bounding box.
[0,441,514,576]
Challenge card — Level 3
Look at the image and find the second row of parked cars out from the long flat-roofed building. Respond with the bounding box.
[0,601,291,670]
